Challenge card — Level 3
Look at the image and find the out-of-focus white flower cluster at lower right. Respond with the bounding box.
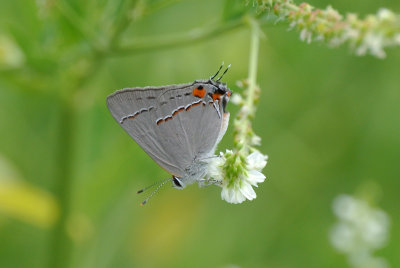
[330,195,389,268]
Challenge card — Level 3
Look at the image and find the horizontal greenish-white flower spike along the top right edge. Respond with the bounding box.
[255,0,400,58]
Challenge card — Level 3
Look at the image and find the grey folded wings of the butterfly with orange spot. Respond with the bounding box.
[107,82,223,176]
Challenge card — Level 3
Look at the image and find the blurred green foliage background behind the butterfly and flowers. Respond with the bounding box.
[0,0,400,268]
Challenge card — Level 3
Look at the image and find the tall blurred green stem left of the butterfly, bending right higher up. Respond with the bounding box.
[49,2,138,268]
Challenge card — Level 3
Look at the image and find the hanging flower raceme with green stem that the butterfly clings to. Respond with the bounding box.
[207,20,268,204]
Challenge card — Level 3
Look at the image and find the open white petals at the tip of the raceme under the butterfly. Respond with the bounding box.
[208,150,268,204]
